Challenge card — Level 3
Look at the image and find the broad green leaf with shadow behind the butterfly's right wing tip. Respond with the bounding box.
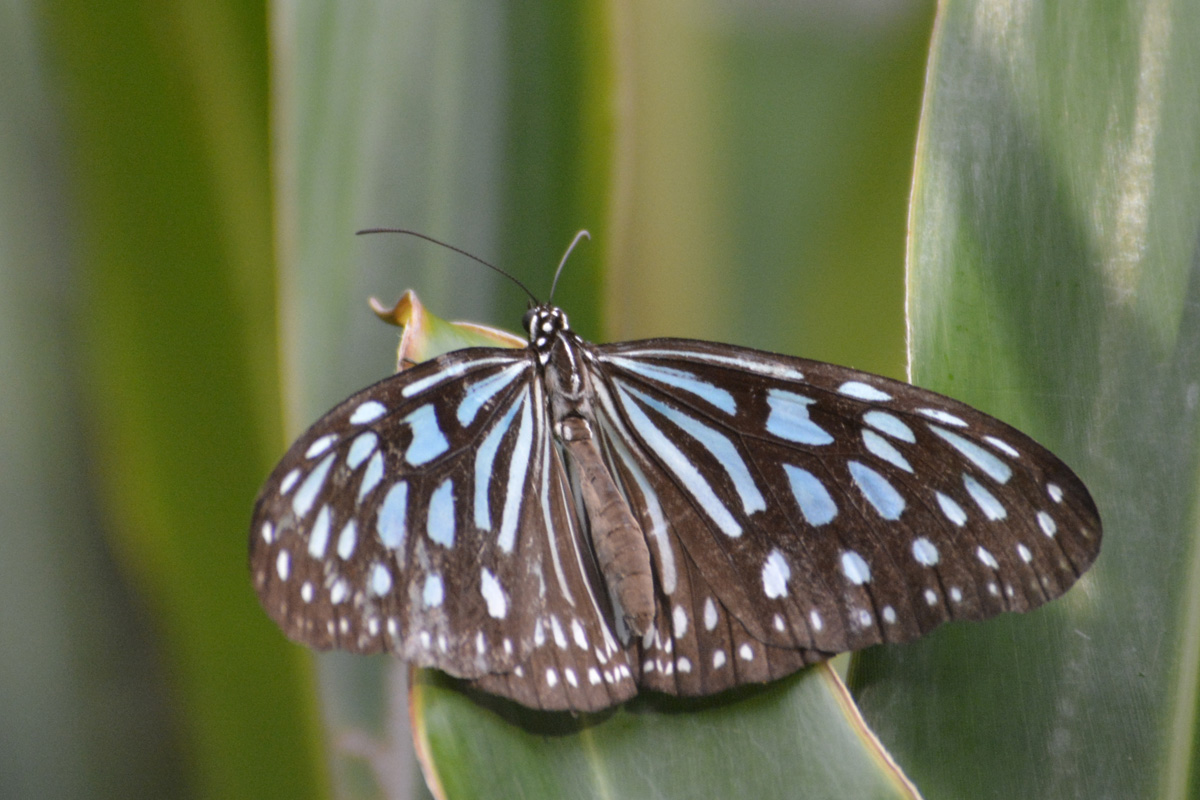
[853,1,1200,798]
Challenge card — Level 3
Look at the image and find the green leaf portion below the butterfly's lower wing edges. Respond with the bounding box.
[413,666,918,800]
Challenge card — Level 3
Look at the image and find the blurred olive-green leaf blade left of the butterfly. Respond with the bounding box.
[42,0,323,798]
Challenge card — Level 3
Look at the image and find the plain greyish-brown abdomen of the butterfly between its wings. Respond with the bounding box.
[559,416,654,636]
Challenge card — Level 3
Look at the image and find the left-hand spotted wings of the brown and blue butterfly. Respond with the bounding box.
[250,349,636,710]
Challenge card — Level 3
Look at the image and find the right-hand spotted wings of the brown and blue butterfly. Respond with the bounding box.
[592,339,1100,694]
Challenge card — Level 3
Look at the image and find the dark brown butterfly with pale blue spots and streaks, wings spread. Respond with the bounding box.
[250,232,1102,711]
